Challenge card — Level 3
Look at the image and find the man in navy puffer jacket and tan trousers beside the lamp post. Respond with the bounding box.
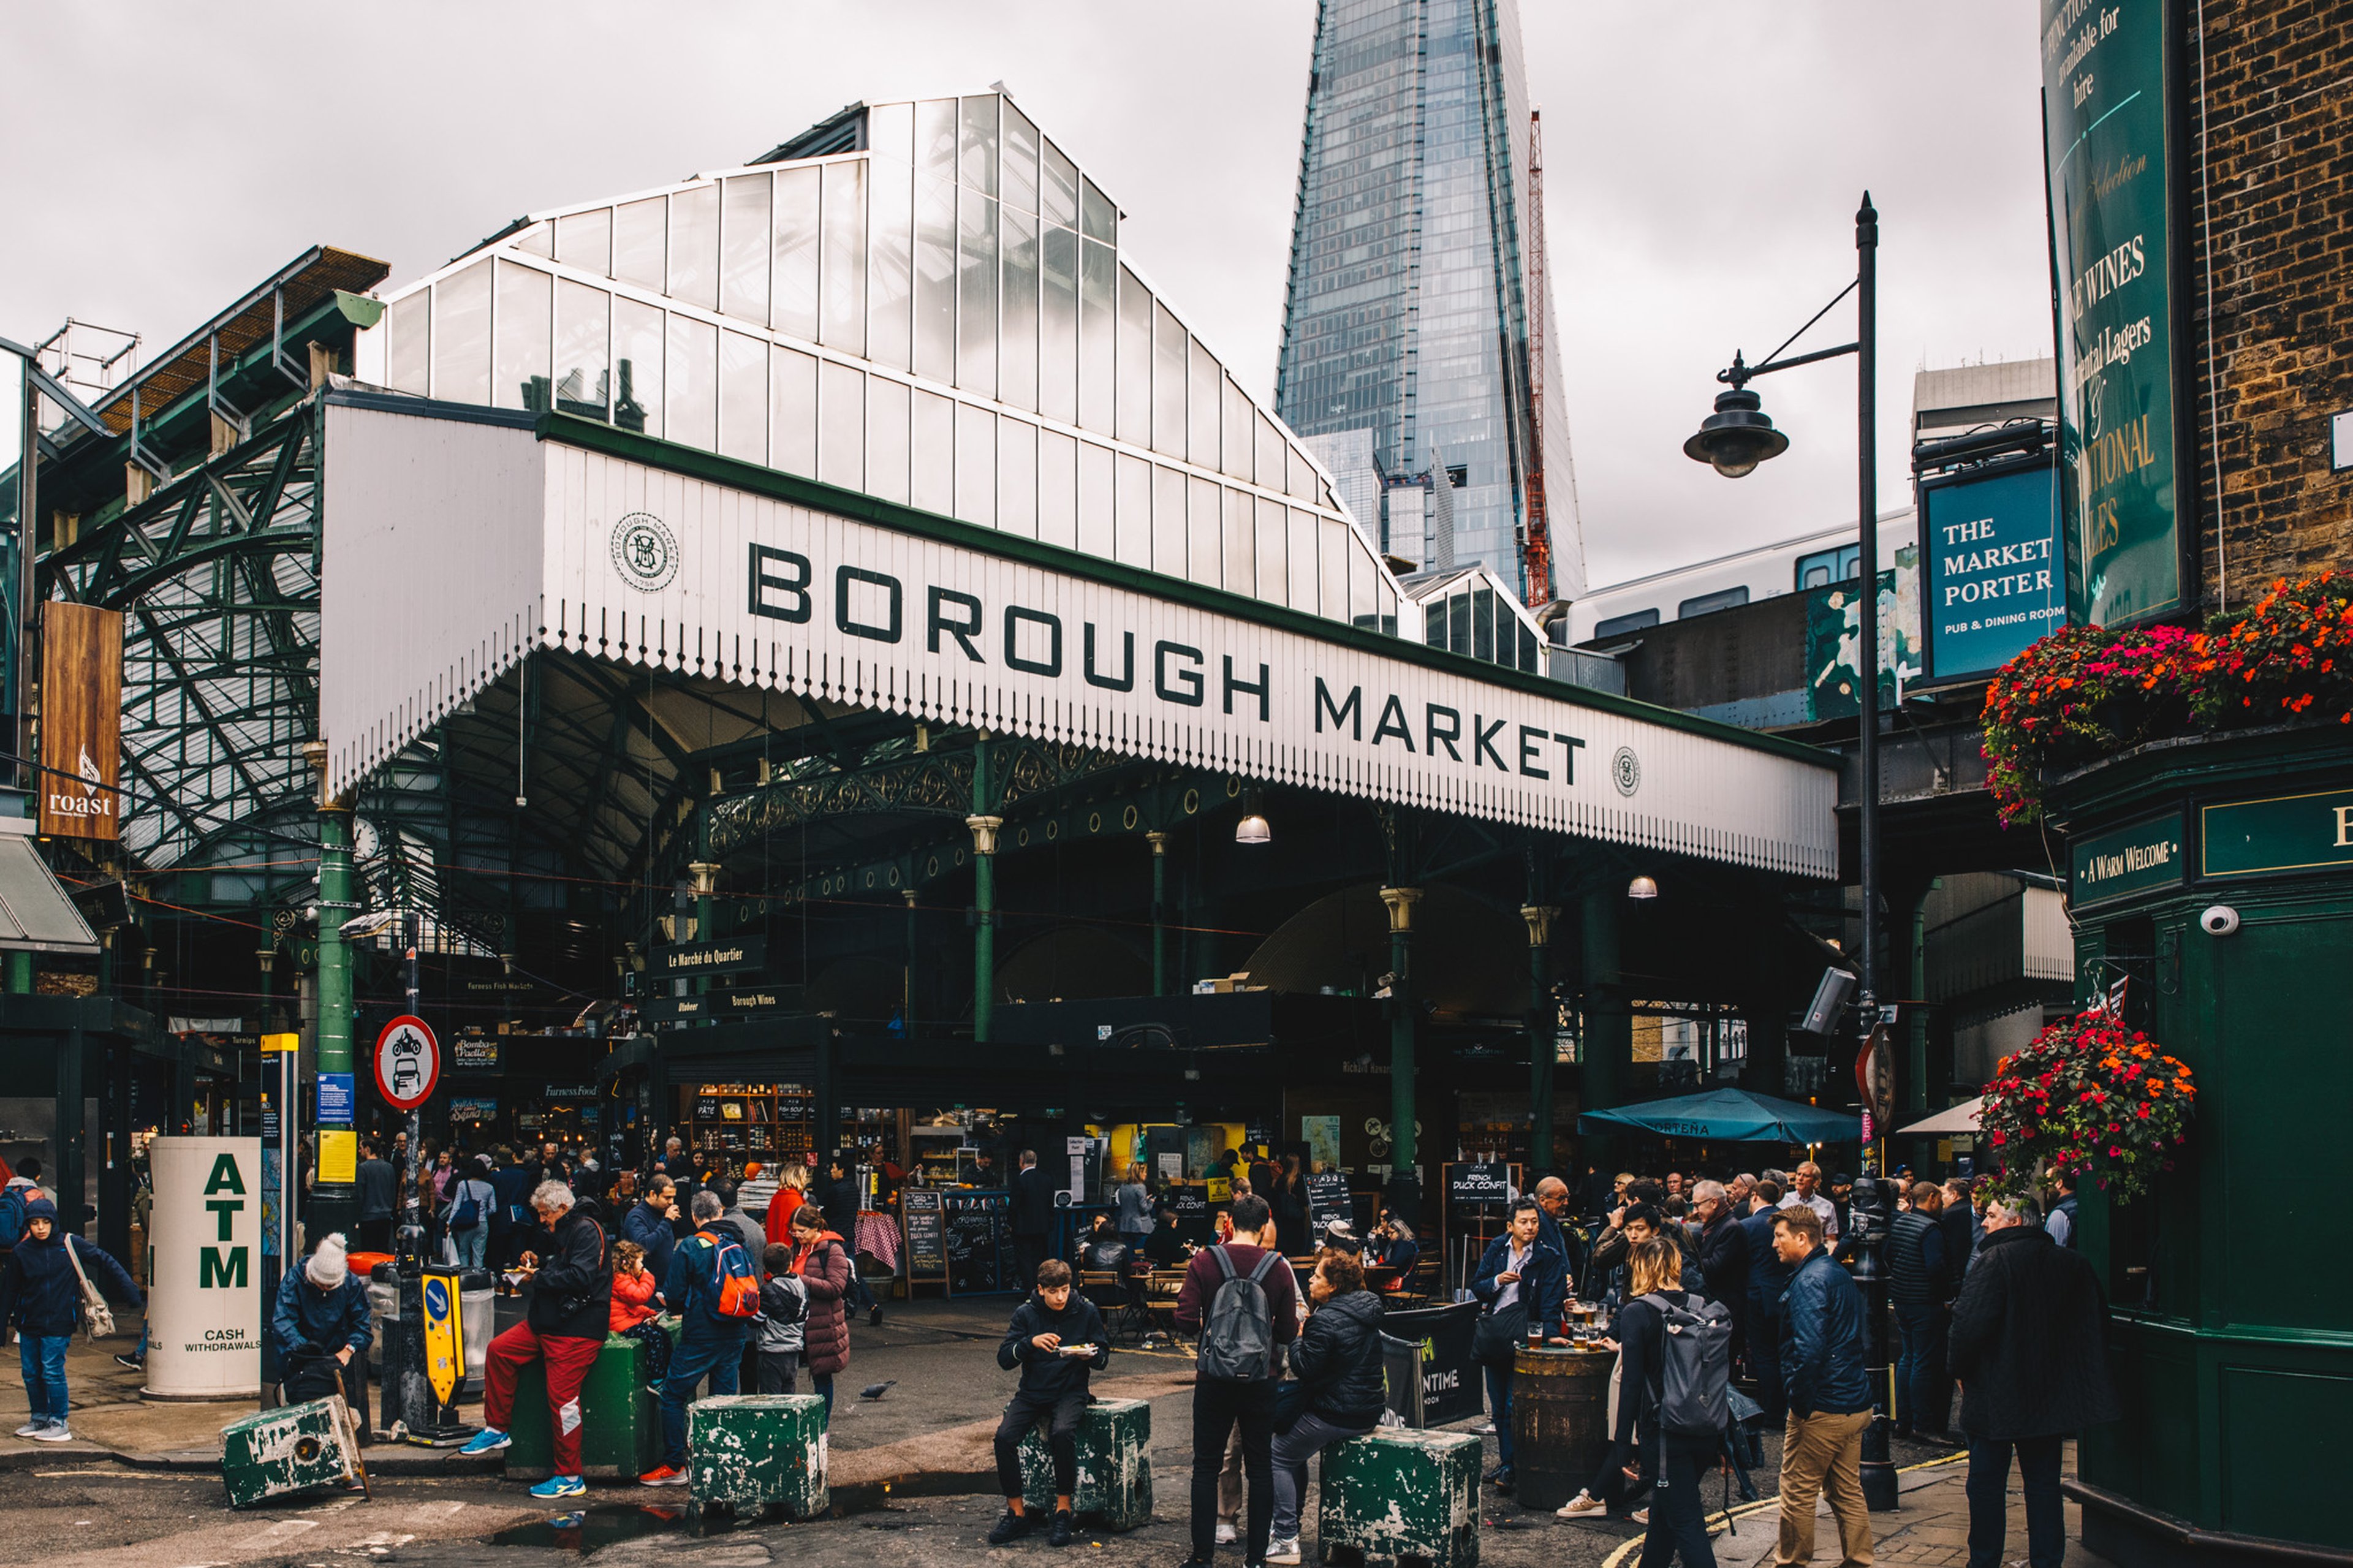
[1772,1205,1871,1563]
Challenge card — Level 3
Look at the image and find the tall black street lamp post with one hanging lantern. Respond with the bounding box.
[1683,191,1896,1509]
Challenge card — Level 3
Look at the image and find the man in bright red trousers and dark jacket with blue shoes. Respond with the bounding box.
[459,1182,612,1498]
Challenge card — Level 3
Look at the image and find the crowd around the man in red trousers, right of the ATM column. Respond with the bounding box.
[248,1137,887,1500]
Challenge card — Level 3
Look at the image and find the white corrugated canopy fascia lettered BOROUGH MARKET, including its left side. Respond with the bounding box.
[322,393,1838,876]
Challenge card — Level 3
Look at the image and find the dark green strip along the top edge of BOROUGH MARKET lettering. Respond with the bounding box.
[539,412,1840,768]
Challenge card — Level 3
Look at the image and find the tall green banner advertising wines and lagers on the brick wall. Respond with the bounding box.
[2040,0,2181,626]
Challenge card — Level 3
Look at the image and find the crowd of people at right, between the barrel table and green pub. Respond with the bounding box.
[1471,1161,2115,1568]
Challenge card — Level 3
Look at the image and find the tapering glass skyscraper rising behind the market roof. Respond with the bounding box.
[1275,0,1583,603]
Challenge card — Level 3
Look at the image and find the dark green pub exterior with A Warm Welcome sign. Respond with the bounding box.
[2054,725,2353,1563]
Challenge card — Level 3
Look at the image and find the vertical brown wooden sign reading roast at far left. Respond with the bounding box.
[40,598,123,841]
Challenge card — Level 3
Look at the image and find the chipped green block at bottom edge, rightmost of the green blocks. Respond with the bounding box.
[1316,1426,1480,1568]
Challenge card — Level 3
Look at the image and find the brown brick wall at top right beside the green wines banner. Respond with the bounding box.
[2181,0,2353,610]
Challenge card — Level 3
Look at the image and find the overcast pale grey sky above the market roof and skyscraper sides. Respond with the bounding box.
[0,0,2052,584]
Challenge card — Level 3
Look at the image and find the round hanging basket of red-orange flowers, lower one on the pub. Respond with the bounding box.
[1977,1012,2198,1203]
